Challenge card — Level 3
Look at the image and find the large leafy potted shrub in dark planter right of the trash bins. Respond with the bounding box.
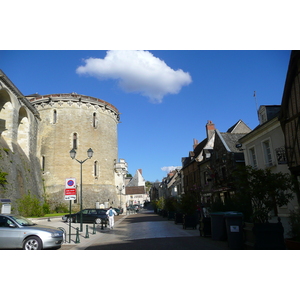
[235,166,293,250]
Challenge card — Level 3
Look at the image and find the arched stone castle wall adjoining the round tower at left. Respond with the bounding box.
[0,70,43,206]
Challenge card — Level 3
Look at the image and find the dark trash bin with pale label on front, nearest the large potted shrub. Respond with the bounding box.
[224,212,244,250]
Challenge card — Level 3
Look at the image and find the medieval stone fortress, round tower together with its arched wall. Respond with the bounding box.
[0,71,126,211]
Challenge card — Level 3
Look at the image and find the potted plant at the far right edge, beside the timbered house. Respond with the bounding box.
[285,208,300,250]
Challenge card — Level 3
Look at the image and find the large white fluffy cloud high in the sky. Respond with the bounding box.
[76,50,192,103]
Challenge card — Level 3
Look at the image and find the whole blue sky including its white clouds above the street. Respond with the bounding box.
[0,50,290,181]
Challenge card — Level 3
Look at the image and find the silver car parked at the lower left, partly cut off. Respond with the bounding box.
[0,214,63,250]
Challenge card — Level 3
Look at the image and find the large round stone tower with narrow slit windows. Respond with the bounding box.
[30,93,119,208]
